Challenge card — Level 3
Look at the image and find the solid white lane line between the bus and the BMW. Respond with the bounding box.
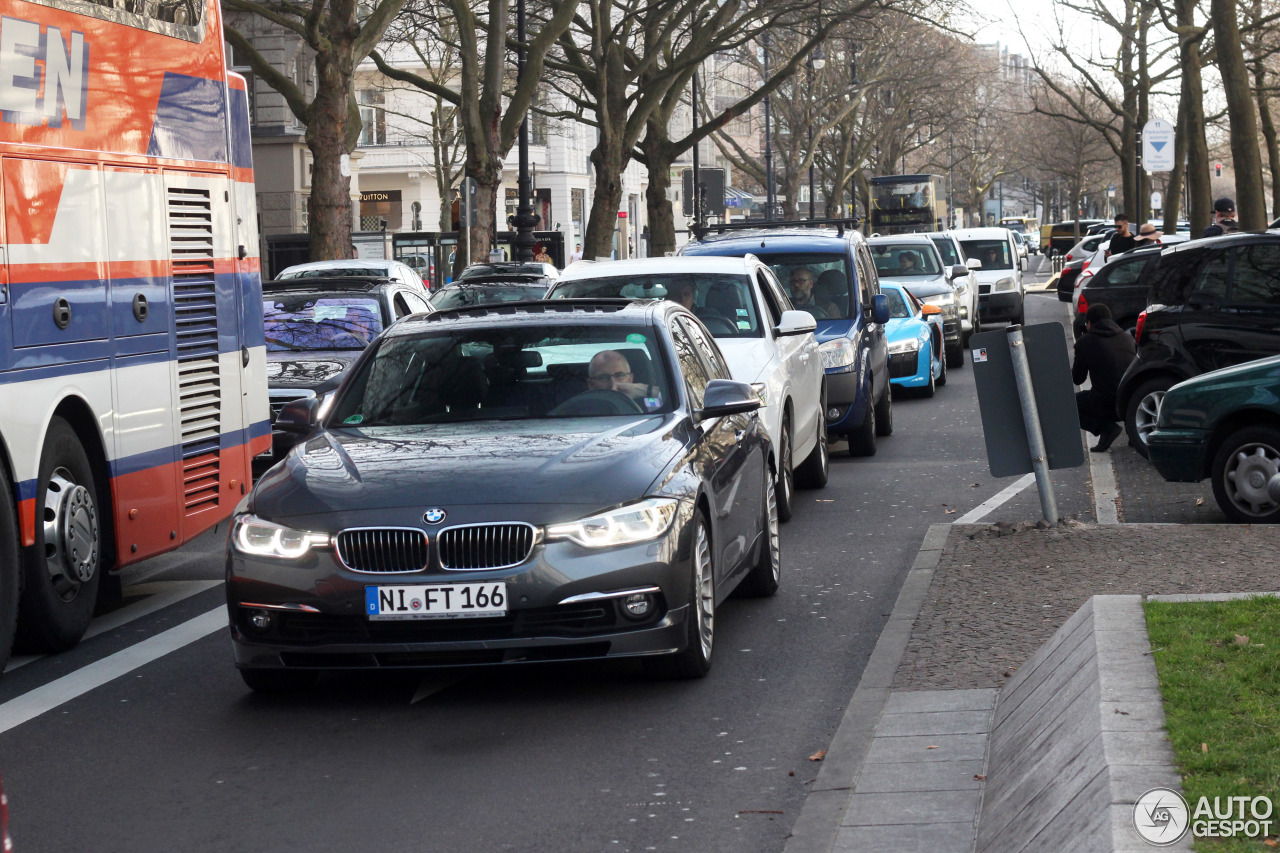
[0,606,227,734]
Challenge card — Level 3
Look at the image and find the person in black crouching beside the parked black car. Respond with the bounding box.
[1071,302,1135,453]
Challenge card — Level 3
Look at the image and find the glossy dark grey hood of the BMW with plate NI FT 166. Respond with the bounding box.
[252,414,684,519]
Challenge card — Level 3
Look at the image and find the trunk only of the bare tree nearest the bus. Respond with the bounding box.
[306,54,353,261]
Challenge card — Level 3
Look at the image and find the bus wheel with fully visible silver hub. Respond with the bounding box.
[18,418,102,652]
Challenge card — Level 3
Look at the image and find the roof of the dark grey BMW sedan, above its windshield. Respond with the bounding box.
[385,300,675,336]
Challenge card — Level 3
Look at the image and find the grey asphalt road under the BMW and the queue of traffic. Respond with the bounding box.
[0,275,1091,853]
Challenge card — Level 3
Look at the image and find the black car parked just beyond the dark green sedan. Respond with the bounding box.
[1116,232,1280,456]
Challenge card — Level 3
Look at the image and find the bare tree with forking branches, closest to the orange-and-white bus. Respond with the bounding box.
[223,0,404,260]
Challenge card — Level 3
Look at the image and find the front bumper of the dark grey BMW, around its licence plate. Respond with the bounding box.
[227,506,692,670]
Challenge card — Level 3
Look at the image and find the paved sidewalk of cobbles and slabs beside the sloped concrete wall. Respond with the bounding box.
[787,524,1280,853]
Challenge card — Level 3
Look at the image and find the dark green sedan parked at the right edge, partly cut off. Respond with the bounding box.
[1148,356,1280,524]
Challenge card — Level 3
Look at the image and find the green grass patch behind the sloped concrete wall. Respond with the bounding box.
[1146,597,1280,853]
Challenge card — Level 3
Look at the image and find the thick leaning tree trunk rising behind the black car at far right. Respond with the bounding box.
[1210,0,1267,231]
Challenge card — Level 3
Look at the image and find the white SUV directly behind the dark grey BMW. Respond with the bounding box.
[547,255,828,521]
